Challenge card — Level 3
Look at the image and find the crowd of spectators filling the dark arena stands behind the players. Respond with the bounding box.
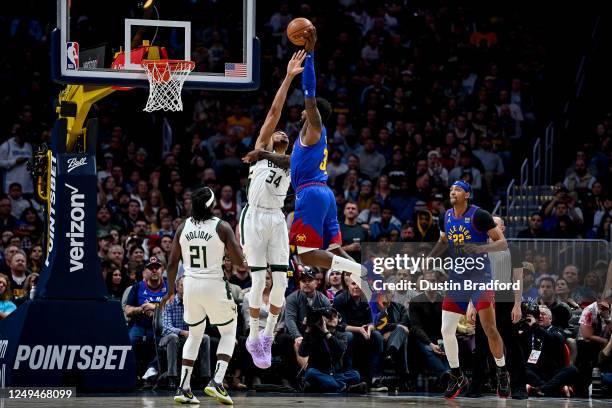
[0,0,612,395]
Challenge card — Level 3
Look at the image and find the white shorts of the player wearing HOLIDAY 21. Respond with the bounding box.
[183,276,237,326]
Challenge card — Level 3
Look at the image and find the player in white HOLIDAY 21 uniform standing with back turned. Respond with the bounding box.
[166,187,246,405]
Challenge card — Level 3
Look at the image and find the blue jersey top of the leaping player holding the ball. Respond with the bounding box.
[291,127,327,190]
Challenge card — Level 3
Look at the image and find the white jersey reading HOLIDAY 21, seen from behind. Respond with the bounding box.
[179,217,225,278]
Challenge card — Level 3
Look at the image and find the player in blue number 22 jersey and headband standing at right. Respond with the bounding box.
[430,181,510,399]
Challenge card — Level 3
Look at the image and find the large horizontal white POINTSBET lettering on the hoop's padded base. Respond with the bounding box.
[13,344,132,370]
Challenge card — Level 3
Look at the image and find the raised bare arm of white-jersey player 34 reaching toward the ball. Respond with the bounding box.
[255,50,306,149]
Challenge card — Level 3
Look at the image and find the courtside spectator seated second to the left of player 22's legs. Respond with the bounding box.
[376,292,410,382]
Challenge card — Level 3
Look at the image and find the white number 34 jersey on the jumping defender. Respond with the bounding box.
[247,159,291,208]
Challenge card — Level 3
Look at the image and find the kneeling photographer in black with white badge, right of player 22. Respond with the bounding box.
[521,305,578,397]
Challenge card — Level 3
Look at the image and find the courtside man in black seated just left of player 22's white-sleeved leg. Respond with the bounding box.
[409,271,449,378]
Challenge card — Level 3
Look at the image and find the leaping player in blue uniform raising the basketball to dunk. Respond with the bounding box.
[245,27,371,299]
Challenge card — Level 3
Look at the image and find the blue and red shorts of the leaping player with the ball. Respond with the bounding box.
[289,183,342,249]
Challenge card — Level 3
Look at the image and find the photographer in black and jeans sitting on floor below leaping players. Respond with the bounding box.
[299,307,367,393]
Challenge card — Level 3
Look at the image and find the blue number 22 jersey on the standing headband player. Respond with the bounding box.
[444,205,491,279]
